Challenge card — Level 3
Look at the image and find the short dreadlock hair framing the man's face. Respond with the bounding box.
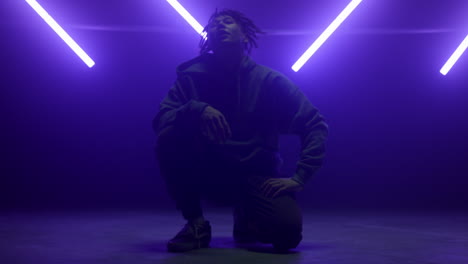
[199,9,265,54]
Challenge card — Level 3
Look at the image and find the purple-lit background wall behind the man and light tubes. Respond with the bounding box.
[0,0,468,209]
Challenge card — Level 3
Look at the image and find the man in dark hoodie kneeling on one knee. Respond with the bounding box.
[153,7,328,252]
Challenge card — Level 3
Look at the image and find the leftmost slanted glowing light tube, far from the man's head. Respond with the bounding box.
[26,0,95,68]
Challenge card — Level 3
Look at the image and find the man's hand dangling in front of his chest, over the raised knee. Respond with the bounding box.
[200,106,231,144]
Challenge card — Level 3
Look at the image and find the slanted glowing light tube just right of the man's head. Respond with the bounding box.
[292,0,362,72]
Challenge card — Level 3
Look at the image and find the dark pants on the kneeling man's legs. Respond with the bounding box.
[156,127,302,248]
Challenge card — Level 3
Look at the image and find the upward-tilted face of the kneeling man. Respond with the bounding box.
[208,15,247,48]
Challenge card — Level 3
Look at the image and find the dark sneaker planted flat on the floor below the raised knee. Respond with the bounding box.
[167,221,211,252]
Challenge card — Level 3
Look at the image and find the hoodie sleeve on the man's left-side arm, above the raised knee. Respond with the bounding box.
[153,76,208,135]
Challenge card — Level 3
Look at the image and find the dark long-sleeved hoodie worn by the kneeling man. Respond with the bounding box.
[153,54,328,185]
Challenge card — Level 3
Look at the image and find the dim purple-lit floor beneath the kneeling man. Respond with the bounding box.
[0,209,468,264]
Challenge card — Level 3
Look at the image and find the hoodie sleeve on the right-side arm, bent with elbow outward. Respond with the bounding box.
[274,76,328,185]
